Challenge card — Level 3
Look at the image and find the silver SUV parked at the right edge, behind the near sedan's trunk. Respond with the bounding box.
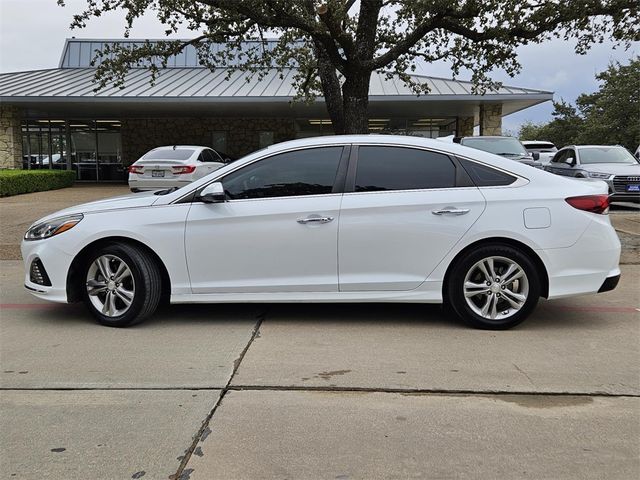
[545,145,640,202]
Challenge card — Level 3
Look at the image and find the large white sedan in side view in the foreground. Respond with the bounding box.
[22,135,620,329]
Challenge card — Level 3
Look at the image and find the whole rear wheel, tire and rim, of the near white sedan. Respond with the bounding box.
[446,245,540,330]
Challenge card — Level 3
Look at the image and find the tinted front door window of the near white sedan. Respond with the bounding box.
[222,147,342,199]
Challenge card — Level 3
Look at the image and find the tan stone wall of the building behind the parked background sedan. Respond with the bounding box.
[121,118,295,166]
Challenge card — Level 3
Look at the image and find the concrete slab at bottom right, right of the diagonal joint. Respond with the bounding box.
[185,391,640,480]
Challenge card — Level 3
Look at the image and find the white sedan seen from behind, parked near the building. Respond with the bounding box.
[129,145,227,192]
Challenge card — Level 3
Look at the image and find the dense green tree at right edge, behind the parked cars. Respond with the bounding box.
[518,58,640,151]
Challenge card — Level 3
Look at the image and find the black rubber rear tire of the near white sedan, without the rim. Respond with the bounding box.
[445,244,540,330]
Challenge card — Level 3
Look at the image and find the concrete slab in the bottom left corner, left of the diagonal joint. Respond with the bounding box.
[0,390,219,480]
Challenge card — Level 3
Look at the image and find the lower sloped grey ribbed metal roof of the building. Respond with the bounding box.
[0,68,553,103]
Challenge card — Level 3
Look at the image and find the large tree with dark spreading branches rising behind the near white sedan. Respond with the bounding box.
[58,0,640,133]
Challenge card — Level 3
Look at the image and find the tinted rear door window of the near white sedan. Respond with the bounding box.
[355,146,456,192]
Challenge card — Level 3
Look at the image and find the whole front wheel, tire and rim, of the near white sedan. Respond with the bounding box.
[82,244,162,327]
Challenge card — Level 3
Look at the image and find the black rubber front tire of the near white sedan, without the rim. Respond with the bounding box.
[81,243,162,327]
